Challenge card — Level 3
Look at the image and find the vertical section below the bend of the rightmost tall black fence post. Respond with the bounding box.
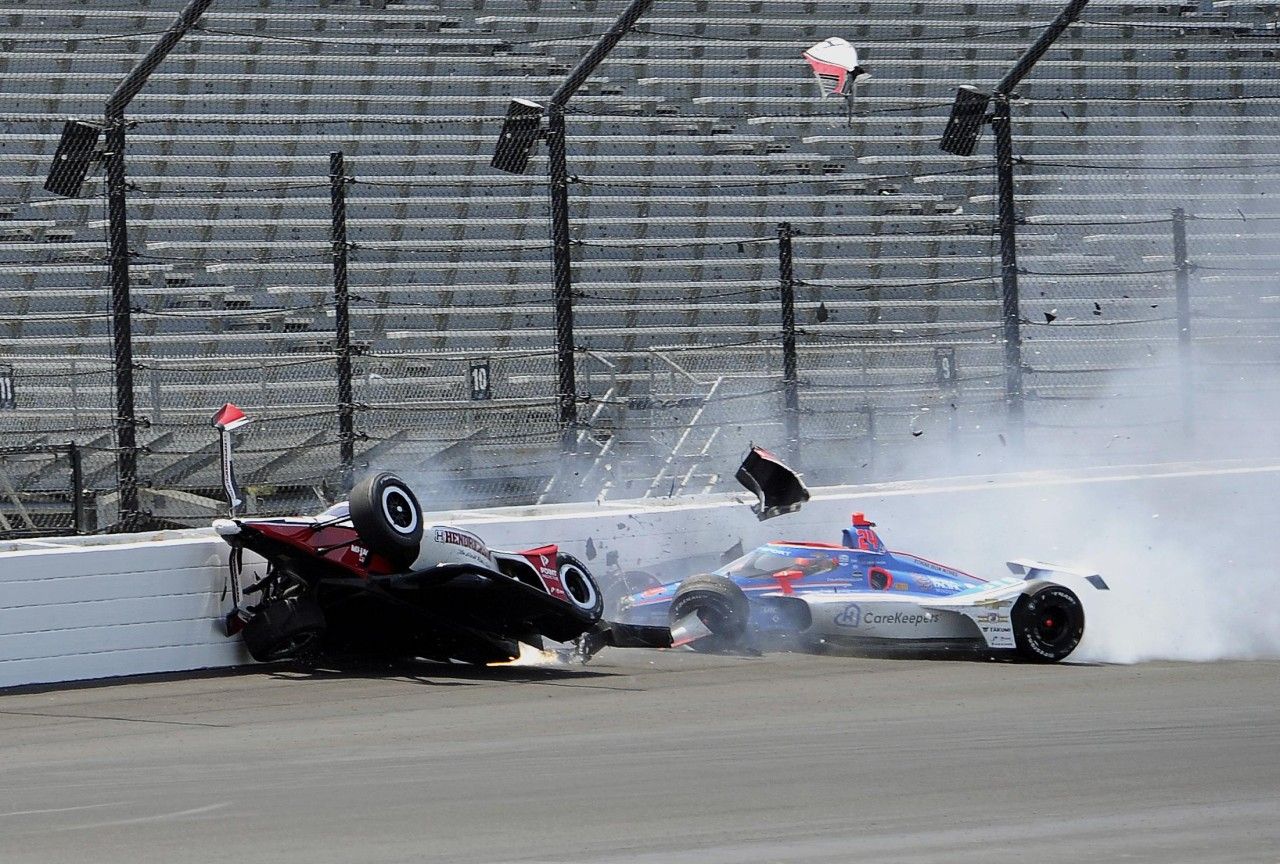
[991,93,1024,444]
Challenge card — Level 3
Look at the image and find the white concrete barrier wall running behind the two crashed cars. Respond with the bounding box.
[0,463,1280,687]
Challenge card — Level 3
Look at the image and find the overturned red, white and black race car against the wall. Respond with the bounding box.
[215,474,614,663]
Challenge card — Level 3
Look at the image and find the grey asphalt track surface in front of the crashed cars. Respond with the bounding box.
[0,650,1280,864]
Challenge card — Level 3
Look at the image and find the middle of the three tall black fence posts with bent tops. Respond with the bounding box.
[547,0,654,435]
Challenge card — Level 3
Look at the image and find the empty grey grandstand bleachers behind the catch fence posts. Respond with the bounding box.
[0,0,1280,519]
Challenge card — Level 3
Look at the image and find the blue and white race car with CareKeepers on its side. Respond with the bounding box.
[612,513,1107,663]
